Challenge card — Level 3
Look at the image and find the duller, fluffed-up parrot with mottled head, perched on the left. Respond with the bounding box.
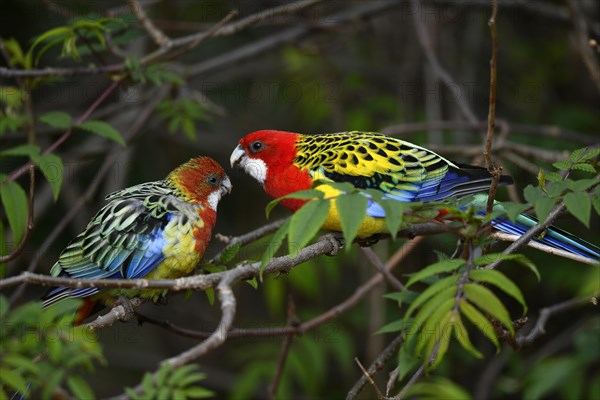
[43,157,232,321]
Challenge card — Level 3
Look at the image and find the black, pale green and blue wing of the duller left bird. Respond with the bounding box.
[45,183,189,305]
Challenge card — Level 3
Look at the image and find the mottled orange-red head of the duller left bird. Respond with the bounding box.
[167,157,232,211]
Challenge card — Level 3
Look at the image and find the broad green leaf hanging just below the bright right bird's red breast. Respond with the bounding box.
[288,199,330,257]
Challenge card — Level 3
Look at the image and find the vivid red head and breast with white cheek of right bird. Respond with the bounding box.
[230,130,312,210]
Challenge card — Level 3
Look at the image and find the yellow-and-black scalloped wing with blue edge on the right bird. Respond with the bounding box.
[294,132,510,217]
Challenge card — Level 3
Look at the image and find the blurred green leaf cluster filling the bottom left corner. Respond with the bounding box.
[0,296,104,399]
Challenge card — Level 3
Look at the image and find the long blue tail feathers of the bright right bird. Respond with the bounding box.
[492,214,600,261]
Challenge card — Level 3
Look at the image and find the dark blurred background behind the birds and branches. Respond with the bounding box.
[0,0,600,398]
